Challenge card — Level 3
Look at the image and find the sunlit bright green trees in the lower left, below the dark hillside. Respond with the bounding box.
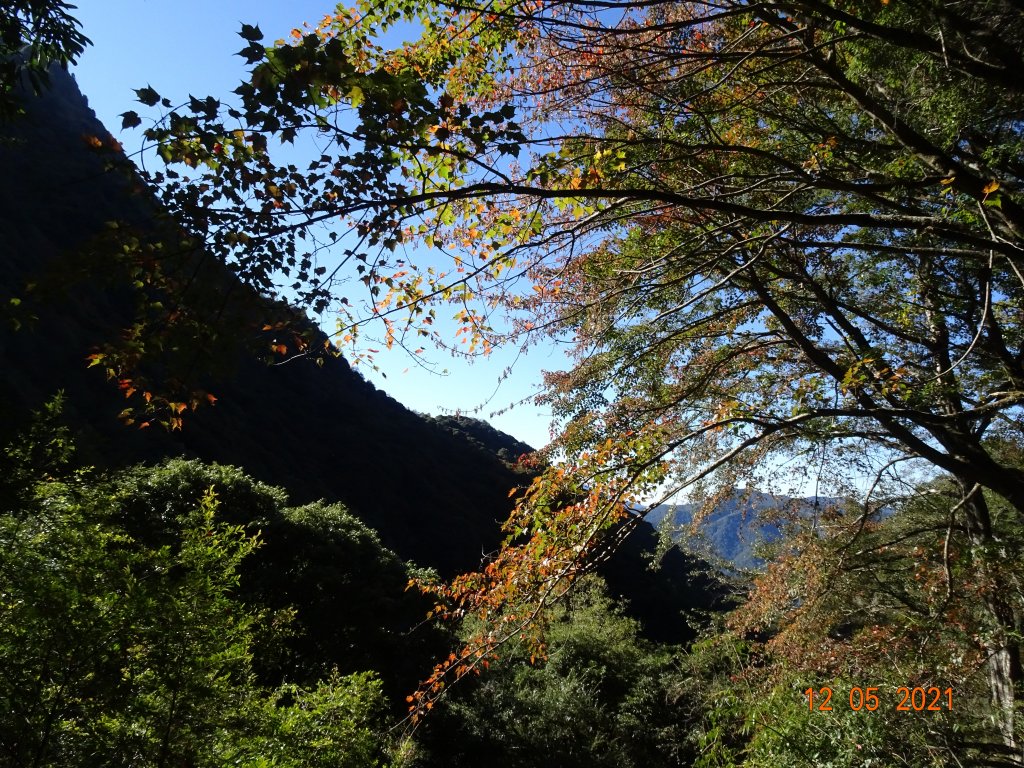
[0,402,400,768]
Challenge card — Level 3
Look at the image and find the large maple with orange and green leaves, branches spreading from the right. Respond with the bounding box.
[9,0,1024,753]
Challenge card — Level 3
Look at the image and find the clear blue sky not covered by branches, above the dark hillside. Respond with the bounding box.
[74,0,566,447]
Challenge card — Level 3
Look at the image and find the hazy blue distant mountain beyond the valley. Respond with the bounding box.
[645,489,840,569]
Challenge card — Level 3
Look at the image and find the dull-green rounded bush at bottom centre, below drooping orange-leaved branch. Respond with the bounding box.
[425,577,689,768]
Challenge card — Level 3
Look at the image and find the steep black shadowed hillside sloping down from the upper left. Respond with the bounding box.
[0,64,719,642]
